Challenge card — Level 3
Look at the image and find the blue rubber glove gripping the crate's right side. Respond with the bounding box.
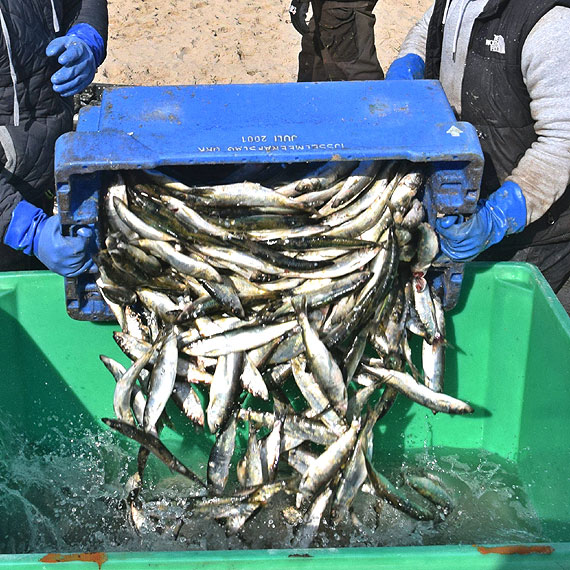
[435,181,526,261]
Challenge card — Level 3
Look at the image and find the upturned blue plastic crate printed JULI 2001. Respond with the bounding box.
[55,80,483,320]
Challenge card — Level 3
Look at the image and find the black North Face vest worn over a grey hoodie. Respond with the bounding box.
[425,0,570,248]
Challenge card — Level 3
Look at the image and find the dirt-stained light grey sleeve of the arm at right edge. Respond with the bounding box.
[507,6,570,223]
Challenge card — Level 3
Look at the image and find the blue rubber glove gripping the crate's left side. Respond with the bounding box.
[4,200,95,277]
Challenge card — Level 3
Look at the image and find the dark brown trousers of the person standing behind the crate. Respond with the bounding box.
[297,0,384,82]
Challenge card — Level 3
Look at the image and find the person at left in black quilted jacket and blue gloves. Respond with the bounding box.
[0,0,108,276]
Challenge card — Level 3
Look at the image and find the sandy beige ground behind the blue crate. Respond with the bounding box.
[95,0,431,85]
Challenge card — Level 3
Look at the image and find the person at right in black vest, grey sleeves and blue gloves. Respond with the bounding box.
[386,0,570,312]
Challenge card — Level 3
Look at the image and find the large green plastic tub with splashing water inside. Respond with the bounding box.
[0,263,570,570]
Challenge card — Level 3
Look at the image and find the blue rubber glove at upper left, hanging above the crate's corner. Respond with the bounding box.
[46,24,105,97]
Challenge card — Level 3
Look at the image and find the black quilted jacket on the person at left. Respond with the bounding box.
[0,0,108,253]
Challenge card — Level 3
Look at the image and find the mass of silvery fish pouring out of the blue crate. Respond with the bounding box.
[97,161,473,547]
